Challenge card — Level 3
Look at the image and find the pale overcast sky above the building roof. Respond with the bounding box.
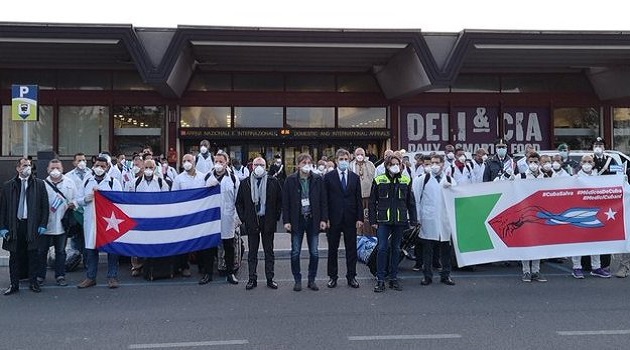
[0,0,630,32]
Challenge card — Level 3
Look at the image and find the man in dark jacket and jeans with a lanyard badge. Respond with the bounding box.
[282,153,328,292]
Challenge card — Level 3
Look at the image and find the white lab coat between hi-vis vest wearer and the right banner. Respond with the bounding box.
[412,173,457,242]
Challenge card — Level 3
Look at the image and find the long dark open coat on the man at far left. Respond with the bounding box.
[0,176,49,252]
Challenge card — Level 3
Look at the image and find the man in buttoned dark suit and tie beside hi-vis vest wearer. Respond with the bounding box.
[324,149,363,288]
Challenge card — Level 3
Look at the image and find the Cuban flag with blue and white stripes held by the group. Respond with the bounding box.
[94,186,221,258]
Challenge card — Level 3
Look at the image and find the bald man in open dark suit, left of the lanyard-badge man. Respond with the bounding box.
[236,157,282,290]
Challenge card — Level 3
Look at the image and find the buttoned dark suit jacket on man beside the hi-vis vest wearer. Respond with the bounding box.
[324,169,364,226]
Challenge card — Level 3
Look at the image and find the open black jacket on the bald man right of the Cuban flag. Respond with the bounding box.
[236,176,282,235]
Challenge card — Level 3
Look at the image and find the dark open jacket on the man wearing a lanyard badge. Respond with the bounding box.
[282,171,328,232]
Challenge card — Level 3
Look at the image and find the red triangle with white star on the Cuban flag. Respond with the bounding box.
[94,191,137,249]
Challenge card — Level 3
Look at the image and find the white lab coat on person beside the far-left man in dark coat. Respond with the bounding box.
[45,175,77,235]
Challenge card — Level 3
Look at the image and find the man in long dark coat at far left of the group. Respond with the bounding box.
[0,158,49,295]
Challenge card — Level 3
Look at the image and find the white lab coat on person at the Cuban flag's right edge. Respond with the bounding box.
[206,171,241,239]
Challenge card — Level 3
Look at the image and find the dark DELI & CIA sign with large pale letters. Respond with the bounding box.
[400,106,550,153]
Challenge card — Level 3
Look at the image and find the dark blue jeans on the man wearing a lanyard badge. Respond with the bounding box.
[291,216,319,282]
